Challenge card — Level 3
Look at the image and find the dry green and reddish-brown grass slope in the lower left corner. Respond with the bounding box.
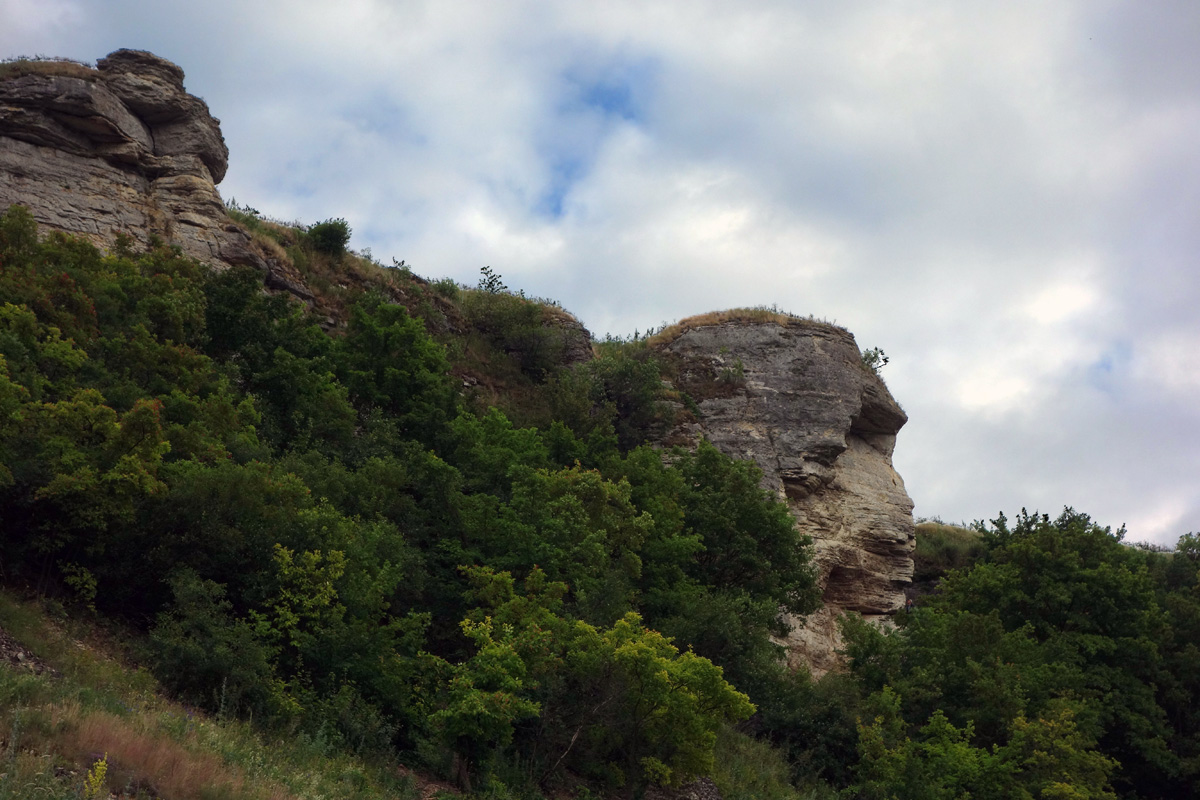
[0,594,418,800]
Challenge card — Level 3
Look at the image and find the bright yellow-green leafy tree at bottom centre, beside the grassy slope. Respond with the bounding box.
[436,569,754,792]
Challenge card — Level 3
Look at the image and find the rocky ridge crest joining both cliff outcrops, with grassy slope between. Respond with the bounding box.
[0,50,913,674]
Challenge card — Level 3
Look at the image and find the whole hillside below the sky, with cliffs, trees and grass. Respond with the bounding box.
[0,50,1200,800]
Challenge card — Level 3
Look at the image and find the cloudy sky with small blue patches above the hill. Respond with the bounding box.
[0,0,1200,545]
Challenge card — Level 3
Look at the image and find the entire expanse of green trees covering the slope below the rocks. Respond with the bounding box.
[0,209,1200,799]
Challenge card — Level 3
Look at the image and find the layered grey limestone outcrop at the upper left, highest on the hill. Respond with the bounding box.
[0,50,311,297]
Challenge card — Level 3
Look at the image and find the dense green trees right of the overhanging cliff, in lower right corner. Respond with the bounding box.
[847,509,1200,798]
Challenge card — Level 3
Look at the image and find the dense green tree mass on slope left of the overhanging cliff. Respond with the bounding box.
[0,207,815,790]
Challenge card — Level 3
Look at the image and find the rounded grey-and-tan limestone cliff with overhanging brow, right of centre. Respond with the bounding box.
[661,320,914,674]
